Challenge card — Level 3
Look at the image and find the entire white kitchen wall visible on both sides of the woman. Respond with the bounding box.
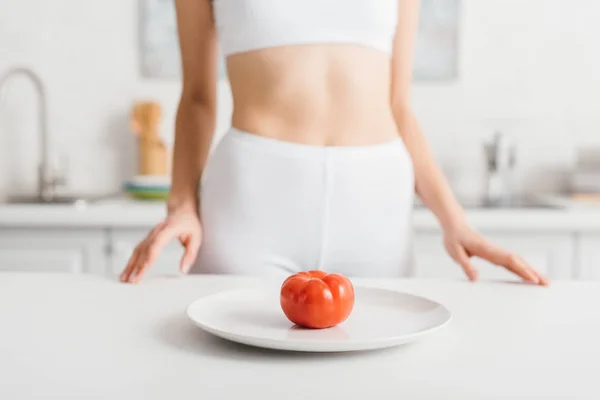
[0,0,600,200]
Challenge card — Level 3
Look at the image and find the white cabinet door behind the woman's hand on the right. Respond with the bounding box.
[413,232,576,281]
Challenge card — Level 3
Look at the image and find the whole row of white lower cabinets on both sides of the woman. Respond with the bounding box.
[0,222,584,281]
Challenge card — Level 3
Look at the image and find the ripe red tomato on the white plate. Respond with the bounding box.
[280,271,354,329]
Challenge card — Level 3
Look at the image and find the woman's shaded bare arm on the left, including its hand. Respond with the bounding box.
[120,0,217,283]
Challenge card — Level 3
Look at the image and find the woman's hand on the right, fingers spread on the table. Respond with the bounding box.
[444,224,550,286]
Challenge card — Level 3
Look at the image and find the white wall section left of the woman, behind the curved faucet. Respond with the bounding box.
[0,0,231,195]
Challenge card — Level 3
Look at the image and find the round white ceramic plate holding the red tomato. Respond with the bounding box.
[187,287,451,352]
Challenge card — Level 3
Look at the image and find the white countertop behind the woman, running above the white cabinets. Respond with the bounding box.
[0,199,600,232]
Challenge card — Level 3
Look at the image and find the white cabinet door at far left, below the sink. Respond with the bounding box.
[0,228,107,273]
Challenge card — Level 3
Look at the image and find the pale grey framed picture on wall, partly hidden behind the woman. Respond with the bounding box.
[140,0,460,81]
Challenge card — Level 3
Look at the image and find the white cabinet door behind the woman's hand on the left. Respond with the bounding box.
[110,229,183,276]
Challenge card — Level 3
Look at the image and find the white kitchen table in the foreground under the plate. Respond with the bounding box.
[0,273,600,400]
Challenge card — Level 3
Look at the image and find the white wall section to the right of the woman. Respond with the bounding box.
[414,0,600,197]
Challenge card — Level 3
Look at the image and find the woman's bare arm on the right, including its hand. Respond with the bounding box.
[391,0,548,285]
